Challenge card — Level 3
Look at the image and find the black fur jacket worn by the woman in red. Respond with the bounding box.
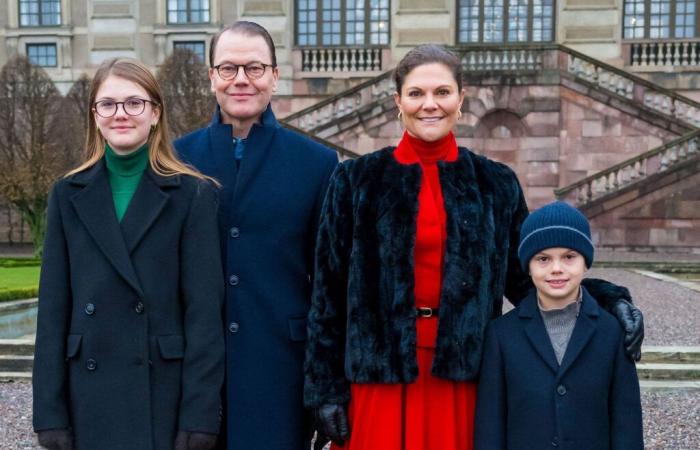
[304,148,629,407]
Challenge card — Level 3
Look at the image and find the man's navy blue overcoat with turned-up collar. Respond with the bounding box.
[175,106,338,450]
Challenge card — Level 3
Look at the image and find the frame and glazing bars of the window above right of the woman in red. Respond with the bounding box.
[455,0,557,45]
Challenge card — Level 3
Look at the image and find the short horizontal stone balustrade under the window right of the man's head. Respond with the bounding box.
[300,47,382,73]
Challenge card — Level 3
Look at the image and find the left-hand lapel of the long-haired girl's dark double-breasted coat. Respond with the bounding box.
[71,159,143,296]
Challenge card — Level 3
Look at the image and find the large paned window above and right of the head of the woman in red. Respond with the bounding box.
[457,0,554,43]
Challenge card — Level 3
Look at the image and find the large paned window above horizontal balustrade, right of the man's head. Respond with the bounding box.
[296,0,390,46]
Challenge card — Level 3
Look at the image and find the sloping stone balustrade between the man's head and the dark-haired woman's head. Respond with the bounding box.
[283,71,395,137]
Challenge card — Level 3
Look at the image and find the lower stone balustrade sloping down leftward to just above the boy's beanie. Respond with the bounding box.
[554,130,700,206]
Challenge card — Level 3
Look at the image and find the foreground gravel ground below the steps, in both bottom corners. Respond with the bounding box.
[0,383,700,450]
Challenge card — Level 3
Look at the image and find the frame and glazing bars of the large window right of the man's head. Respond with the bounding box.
[294,0,391,48]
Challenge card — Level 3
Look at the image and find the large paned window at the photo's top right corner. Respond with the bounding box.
[624,0,698,39]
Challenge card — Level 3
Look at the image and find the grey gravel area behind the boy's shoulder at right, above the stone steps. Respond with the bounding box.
[589,264,700,346]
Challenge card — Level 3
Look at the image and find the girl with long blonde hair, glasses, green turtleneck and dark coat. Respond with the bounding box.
[33,59,224,450]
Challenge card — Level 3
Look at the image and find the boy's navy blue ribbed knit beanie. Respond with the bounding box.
[518,201,593,273]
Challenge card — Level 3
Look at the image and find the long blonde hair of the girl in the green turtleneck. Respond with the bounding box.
[66,58,219,186]
